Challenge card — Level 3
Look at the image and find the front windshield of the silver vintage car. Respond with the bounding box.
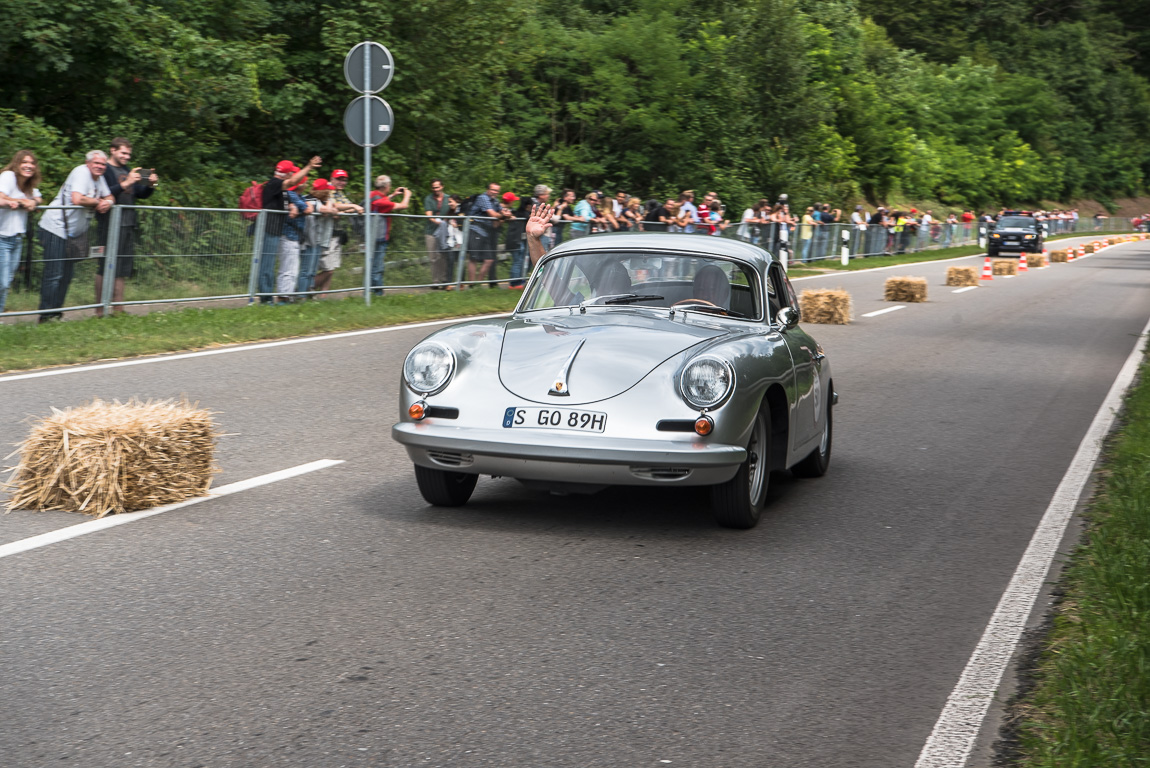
[522,251,761,320]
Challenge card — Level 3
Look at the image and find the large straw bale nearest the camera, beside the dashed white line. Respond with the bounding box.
[7,399,220,517]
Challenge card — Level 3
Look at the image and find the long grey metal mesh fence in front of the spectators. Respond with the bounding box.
[6,206,1132,321]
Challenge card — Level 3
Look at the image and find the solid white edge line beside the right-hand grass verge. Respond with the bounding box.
[914,312,1150,768]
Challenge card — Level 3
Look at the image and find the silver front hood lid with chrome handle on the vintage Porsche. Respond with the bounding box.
[499,308,730,406]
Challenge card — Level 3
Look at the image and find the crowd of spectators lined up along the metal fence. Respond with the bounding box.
[0,138,1127,312]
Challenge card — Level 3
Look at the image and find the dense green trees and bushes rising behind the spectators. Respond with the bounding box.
[0,0,1150,206]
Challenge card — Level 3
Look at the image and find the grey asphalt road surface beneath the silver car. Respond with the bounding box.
[0,236,1150,768]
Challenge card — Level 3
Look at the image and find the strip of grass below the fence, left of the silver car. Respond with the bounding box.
[0,289,522,371]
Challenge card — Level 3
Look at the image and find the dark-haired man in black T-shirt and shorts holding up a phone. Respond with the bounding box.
[95,137,160,317]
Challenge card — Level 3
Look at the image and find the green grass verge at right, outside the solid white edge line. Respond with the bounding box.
[1017,351,1150,768]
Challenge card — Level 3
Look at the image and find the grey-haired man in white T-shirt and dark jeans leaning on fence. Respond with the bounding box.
[40,149,115,323]
